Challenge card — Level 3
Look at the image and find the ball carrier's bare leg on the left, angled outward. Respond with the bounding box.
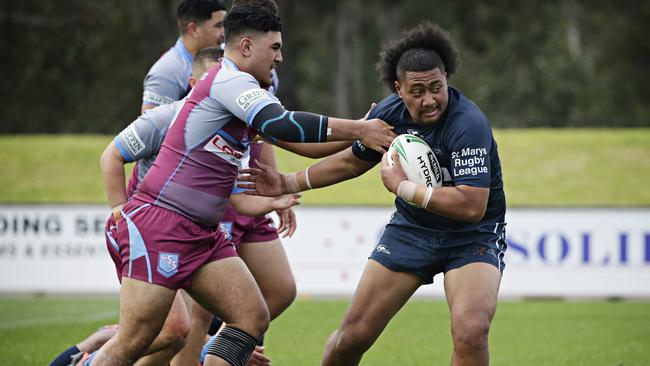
[321,259,422,365]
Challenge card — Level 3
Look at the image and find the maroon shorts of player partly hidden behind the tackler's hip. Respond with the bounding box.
[221,206,278,248]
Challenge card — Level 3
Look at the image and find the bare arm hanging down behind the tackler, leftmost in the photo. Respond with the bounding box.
[99,141,127,221]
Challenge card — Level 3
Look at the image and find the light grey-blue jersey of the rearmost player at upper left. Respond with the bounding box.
[142,38,192,106]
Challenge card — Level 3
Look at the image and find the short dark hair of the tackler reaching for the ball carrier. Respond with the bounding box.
[223,5,282,45]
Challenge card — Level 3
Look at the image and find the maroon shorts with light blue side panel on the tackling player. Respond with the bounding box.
[117,199,237,290]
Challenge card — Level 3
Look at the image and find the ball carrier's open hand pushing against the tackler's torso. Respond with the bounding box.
[237,159,287,197]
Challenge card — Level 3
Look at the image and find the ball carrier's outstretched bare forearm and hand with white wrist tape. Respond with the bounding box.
[237,148,376,196]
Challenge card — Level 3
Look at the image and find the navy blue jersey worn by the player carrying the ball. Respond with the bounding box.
[352,87,506,232]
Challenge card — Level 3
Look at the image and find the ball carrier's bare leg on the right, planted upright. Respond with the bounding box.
[445,263,501,366]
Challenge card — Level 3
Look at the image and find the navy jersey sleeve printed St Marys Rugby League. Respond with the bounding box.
[447,113,492,188]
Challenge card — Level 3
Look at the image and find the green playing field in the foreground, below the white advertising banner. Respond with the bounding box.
[0,298,650,366]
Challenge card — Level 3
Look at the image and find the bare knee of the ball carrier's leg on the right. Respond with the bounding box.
[451,311,492,352]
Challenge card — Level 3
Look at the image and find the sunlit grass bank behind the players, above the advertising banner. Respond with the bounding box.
[0,129,650,207]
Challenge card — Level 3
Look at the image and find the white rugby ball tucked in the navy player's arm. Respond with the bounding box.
[386,134,442,187]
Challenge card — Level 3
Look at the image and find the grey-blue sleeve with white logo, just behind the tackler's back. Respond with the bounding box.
[114,103,177,162]
